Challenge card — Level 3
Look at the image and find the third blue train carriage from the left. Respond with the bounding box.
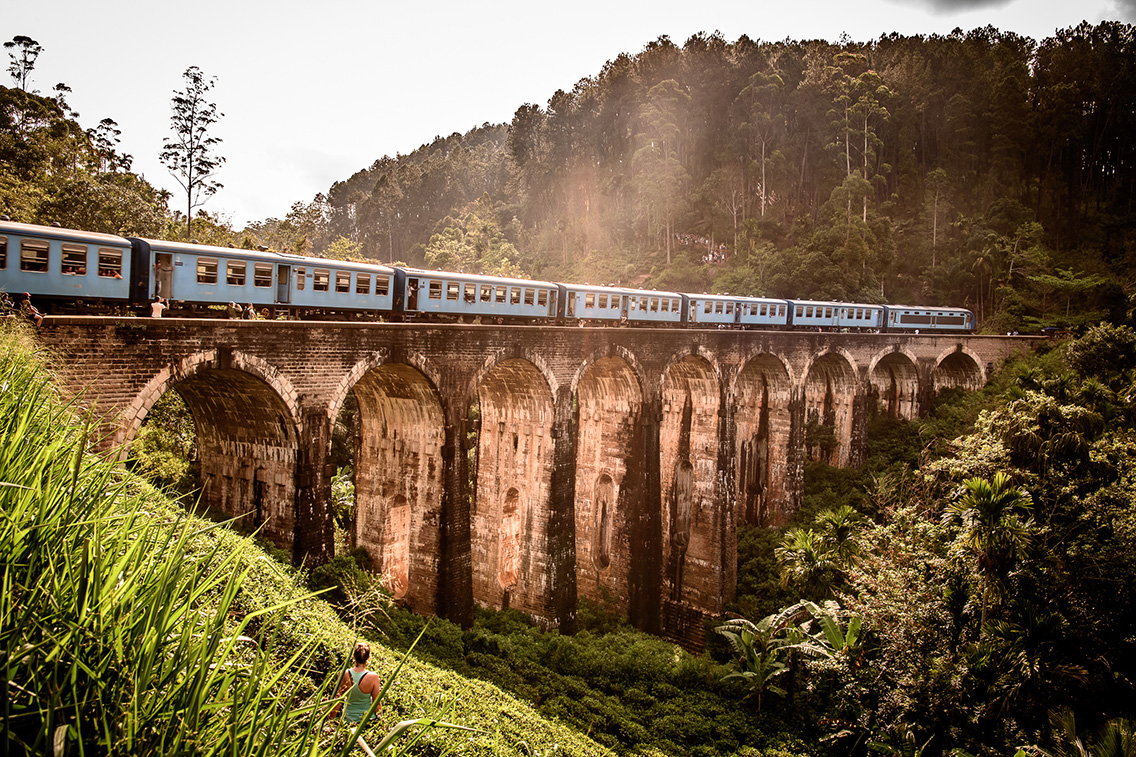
[395,268,558,323]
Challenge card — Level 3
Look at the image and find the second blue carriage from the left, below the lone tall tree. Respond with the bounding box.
[133,240,394,317]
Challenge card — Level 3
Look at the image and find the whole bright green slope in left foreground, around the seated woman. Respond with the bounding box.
[0,322,610,756]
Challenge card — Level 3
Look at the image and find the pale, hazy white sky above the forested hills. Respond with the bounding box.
[0,0,1136,228]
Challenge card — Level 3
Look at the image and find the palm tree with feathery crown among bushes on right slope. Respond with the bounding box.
[946,472,1033,626]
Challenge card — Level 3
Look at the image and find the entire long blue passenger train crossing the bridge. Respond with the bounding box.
[0,221,975,333]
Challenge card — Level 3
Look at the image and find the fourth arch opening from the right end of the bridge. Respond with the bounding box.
[734,355,792,525]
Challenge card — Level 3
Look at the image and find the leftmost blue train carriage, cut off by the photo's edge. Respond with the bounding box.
[0,222,135,313]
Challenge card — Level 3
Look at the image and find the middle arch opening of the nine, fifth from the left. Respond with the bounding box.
[659,356,722,613]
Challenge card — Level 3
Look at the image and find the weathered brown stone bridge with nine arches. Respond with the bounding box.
[40,317,1033,646]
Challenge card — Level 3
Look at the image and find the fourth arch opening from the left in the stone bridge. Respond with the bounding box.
[575,357,643,615]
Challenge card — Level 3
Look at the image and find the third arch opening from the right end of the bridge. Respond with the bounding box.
[804,352,857,467]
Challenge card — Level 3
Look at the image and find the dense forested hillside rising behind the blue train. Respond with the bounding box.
[0,22,1136,333]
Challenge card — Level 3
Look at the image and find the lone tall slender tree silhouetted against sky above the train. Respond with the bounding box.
[158,66,225,239]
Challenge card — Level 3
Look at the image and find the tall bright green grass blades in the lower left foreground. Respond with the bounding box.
[0,320,338,755]
